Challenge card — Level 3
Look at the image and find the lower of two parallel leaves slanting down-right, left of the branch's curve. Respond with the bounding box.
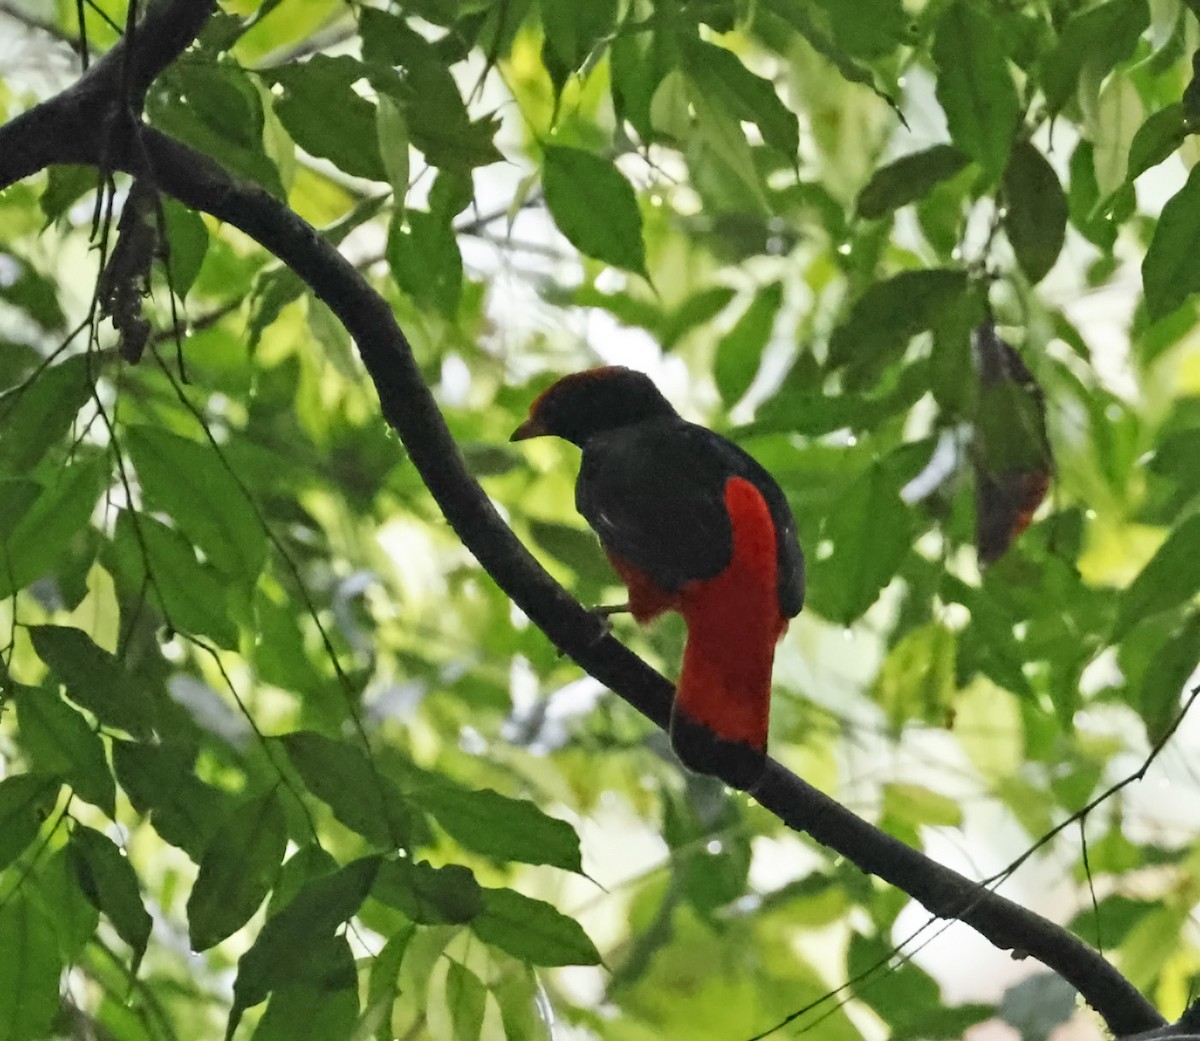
[107,510,238,650]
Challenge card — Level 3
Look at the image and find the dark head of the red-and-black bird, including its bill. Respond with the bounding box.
[511,365,676,447]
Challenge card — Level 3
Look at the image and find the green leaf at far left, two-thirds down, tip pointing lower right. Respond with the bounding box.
[12,686,116,818]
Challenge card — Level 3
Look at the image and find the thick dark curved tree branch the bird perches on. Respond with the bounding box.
[0,0,1164,1034]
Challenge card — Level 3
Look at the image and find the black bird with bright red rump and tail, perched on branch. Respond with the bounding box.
[512,366,804,788]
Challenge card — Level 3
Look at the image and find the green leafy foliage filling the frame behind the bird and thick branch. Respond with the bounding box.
[0,0,1200,1041]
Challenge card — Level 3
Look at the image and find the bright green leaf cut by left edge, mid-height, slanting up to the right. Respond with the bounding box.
[0,458,108,598]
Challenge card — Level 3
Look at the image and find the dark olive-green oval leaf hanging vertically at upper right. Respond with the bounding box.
[1004,142,1067,284]
